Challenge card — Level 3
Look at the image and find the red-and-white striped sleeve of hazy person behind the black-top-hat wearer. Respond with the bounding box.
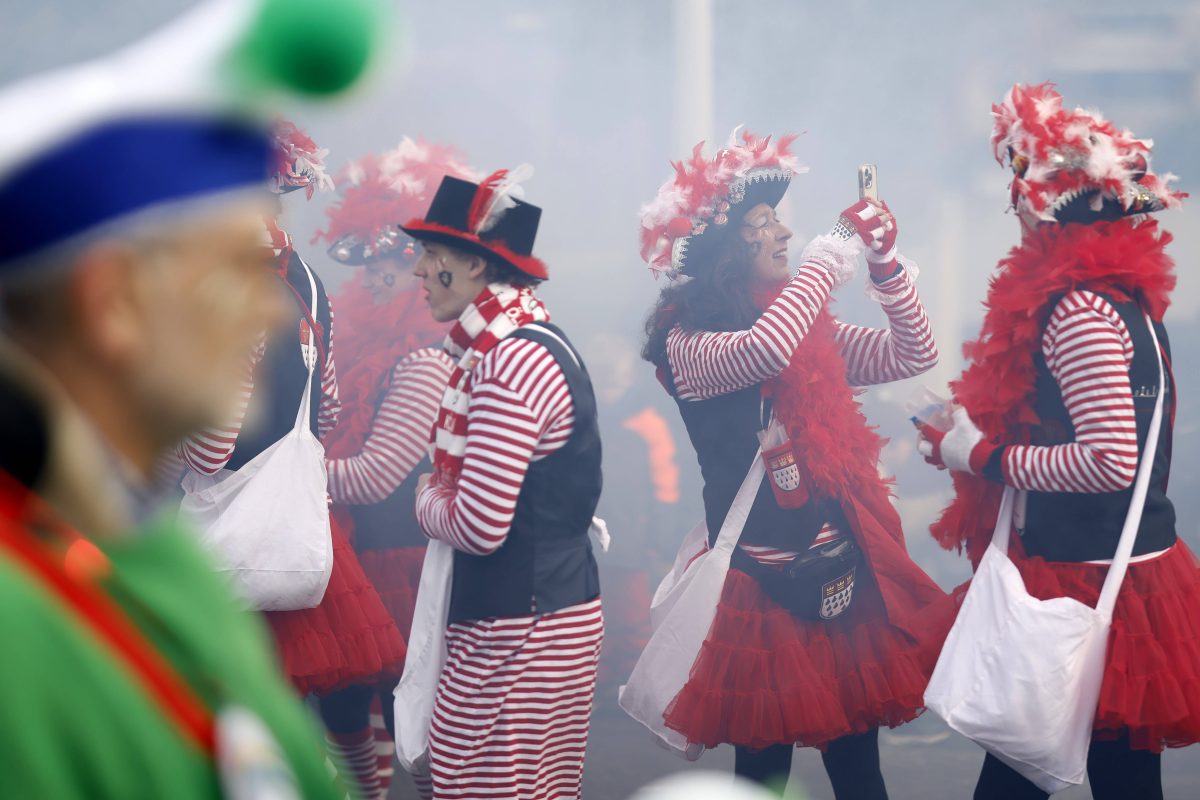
[325,348,454,505]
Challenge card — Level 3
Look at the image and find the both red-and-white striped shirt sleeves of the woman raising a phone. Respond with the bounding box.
[667,264,937,401]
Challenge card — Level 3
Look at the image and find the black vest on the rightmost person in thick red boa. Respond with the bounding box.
[1021,295,1175,561]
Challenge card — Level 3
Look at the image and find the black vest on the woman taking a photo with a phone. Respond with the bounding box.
[676,385,841,552]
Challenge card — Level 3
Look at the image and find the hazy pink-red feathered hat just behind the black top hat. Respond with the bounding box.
[314,137,475,265]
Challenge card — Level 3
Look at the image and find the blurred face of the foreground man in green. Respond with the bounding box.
[123,201,288,441]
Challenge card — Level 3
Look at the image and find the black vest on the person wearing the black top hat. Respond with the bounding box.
[449,325,602,622]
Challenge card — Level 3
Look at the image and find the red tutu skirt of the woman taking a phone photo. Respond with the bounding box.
[665,570,954,750]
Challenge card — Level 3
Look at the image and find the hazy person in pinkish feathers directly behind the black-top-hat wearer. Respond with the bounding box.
[317,138,472,798]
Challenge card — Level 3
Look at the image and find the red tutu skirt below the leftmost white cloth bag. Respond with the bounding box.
[265,519,406,694]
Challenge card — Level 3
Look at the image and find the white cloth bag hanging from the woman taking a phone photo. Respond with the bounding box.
[620,451,764,759]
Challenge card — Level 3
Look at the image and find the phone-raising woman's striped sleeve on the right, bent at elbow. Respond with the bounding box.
[834,266,937,386]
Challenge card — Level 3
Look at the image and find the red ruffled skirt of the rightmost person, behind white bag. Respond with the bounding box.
[1010,541,1200,752]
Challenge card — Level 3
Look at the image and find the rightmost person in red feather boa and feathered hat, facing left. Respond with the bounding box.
[919,84,1200,800]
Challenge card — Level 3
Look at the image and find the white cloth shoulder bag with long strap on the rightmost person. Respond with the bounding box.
[925,317,1165,794]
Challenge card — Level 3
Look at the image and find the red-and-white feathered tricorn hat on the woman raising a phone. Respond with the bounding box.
[642,130,808,276]
